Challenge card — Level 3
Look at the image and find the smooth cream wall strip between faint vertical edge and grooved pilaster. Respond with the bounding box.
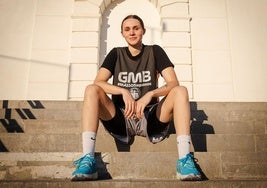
[26,0,73,100]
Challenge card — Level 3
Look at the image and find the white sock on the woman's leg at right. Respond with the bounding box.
[177,135,191,159]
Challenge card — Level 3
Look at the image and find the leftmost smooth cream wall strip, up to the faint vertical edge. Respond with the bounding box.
[0,0,36,99]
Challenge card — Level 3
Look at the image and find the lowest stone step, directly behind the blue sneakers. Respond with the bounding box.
[0,152,267,180]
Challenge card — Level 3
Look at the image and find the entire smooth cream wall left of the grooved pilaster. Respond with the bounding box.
[0,0,74,100]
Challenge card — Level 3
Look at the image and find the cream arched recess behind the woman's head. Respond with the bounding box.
[99,0,161,64]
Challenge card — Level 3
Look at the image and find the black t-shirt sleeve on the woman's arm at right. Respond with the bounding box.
[153,45,174,73]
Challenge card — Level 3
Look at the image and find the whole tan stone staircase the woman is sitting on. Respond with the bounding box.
[0,101,267,188]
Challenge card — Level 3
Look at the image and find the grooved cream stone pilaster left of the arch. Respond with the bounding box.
[69,1,101,100]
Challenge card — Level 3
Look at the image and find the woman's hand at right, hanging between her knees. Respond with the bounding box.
[135,92,153,119]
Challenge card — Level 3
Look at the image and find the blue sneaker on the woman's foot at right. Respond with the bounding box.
[176,153,201,181]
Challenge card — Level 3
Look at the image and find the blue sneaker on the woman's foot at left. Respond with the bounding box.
[71,154,98,181]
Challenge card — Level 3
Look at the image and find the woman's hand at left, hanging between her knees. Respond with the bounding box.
[122,89,136,119]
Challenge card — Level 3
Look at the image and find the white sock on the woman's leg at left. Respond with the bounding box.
[82,131,96,156]
